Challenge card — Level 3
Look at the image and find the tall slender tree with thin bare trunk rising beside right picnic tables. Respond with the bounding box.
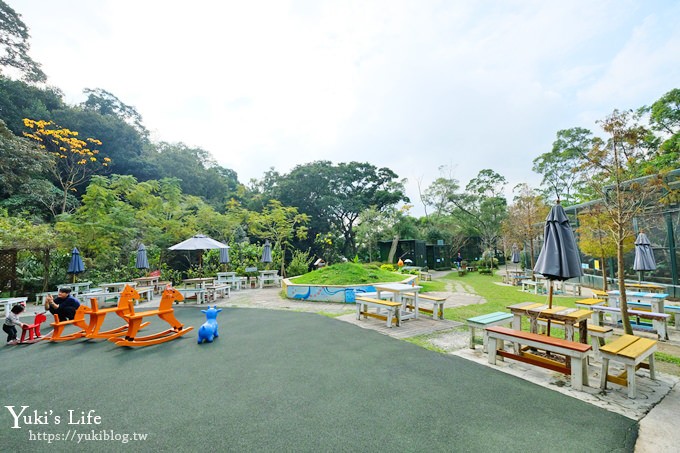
[579,110,658,335]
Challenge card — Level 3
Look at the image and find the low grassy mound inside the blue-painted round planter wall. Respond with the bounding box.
[293,262,407,285]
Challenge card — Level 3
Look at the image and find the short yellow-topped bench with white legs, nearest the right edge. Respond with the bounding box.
[600,335,657,398]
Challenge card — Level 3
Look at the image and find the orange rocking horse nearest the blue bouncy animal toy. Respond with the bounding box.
[109,286,193,346]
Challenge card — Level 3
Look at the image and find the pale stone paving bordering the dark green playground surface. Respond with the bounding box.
[17,275,680,453]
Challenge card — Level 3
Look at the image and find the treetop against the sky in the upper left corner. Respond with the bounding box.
[0,0,47,82]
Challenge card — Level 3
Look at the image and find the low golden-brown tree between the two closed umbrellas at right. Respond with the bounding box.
[576,204,634,291]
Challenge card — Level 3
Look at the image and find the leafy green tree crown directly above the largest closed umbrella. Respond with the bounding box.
[533,127,593,205]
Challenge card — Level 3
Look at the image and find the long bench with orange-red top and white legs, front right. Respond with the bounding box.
[484,326,592,390]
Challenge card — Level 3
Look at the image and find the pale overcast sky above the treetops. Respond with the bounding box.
[6,0,680,215]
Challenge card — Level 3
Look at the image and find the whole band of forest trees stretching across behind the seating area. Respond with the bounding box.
[0,1,680,292]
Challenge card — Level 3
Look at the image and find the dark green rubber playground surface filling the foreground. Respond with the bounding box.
[0,306,638,452]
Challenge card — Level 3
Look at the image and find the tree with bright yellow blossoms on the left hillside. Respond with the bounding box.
[24,118,111,213]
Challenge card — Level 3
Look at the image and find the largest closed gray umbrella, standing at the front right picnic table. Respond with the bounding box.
[534,200,583,312]
